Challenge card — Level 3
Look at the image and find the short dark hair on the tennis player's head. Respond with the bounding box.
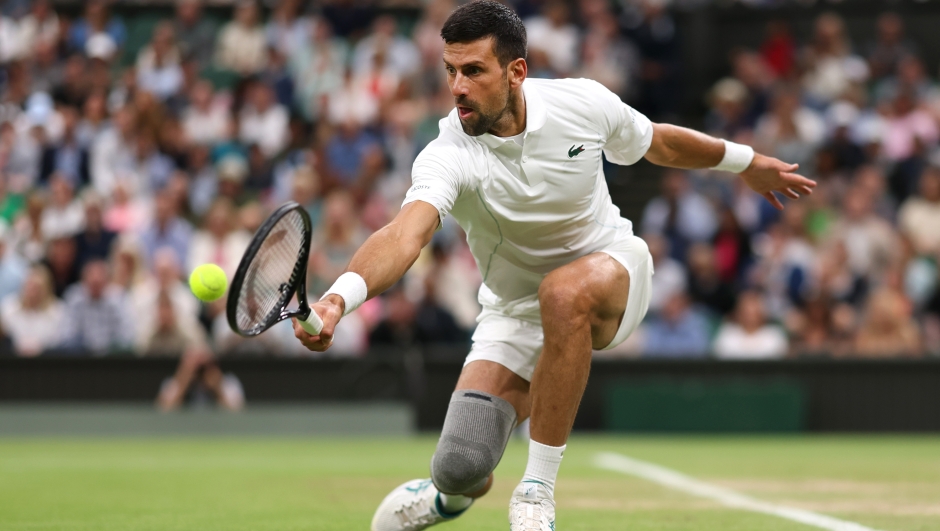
[441,0,526,66]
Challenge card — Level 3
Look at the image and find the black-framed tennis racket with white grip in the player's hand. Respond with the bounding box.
[225,202,323,337]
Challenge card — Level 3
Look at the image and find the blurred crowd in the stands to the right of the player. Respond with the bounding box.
[630,13,940,359]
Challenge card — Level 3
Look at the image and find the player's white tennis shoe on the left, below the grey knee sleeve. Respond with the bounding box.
[372,479,466,531]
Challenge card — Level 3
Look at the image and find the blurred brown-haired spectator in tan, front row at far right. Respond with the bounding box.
[851,289,923,358]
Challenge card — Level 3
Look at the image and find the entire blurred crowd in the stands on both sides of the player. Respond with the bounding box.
[0,0,940,366]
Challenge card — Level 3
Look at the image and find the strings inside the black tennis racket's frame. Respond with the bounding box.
[236,211,306,330]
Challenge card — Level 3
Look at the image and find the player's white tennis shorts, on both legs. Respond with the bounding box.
[464,235,653,381]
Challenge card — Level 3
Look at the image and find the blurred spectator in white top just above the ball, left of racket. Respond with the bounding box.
[186,197,252,278]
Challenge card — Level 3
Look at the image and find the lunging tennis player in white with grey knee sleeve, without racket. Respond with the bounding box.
[294,0,815,531]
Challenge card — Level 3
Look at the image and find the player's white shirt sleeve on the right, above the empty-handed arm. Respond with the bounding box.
[591,82,653,166]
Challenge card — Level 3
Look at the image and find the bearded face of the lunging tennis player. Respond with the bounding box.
[444,37,510,136]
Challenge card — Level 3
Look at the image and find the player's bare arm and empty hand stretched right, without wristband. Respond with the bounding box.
[646,124,816,209]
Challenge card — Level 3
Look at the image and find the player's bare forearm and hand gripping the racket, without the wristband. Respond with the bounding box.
[294,201,440,352]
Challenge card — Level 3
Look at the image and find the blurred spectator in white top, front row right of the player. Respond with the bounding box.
[712,291,788,360]
